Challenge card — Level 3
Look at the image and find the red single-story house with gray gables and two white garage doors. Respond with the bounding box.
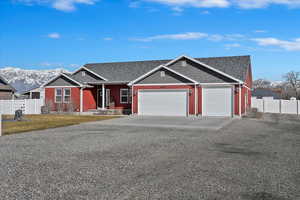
[43,56,252,116]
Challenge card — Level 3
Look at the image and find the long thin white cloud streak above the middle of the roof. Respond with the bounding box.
[131,32,208,42]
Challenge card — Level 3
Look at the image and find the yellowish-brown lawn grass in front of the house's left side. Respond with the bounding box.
[2,114,116,135]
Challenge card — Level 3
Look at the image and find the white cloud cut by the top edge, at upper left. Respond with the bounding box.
[15,0,97,12]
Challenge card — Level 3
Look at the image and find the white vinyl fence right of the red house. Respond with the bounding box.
[251,97,300,115]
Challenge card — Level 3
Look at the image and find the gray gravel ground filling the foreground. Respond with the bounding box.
[0,116,300,200]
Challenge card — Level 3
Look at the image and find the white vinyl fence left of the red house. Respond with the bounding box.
[0,99,44,115]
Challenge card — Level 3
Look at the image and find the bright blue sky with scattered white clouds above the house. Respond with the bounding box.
[0,0,300,80]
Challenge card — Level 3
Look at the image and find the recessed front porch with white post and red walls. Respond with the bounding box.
[83,84,131,115]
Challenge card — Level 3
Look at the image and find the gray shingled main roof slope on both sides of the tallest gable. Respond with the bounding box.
[85,56,250,82]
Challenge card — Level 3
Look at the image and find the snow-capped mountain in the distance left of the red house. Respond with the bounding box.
[0,67,68,93]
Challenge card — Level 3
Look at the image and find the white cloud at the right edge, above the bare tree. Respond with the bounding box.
[252,37,300,51]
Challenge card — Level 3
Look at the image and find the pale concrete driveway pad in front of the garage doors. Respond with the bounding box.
[92,116,234,130]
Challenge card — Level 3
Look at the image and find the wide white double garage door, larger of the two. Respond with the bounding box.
[138,90,187,116]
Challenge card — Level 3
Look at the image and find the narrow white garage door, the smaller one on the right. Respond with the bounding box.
[202,87,232,117]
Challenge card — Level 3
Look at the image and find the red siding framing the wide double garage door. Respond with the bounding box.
[132,85,195,115]
